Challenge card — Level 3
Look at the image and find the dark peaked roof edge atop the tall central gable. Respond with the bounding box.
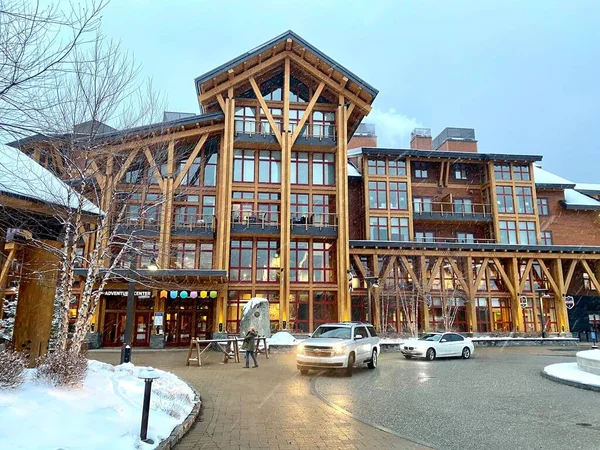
[194,30,379,98]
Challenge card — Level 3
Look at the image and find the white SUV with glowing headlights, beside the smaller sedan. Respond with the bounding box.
[296,322,379,377]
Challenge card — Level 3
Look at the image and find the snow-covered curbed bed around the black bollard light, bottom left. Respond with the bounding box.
[0,361,195,450]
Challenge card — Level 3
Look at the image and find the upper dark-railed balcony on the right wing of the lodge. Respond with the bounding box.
[413,202,493,222]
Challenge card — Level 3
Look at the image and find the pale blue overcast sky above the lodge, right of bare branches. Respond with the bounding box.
[102,0,600,183]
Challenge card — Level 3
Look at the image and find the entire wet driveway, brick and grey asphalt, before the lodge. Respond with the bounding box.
[89,348,600,450]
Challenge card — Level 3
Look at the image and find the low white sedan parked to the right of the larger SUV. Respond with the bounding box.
[400,333,475,361]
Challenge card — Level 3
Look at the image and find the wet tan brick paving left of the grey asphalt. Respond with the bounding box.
[89,350,428,450]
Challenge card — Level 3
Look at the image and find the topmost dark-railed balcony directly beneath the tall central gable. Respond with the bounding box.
[234,118,337,146]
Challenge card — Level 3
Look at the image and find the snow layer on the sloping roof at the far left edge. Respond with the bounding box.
[0,144,101,214]
